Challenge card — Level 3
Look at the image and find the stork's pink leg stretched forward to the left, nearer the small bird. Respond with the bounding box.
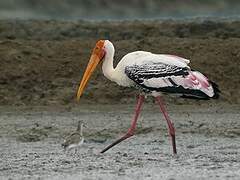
[101,95,145,153]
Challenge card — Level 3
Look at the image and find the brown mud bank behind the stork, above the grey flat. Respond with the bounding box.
[0,19,240,105]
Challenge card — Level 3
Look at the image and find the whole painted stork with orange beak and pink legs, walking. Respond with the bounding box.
[77,40,220,154]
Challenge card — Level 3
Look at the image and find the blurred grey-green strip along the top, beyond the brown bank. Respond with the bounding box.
[0,0,240,20]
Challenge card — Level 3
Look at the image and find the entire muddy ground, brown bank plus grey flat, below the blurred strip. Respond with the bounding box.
[0,19,240,179]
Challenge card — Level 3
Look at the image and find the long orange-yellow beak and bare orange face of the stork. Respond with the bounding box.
[77,40,105,101]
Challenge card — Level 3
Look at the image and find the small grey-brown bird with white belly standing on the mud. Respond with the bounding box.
[62,121,86,153]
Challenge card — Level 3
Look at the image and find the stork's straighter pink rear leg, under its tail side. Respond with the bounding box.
[156,96,177,154]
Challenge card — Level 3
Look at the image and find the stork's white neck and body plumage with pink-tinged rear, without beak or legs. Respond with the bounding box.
[102,40,218,98]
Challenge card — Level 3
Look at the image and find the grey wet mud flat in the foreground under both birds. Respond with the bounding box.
[0,104,240,180]
